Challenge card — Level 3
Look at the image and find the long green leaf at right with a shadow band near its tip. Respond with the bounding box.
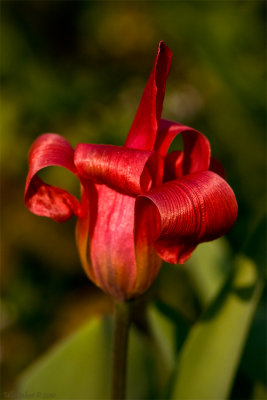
[172,257,263,400]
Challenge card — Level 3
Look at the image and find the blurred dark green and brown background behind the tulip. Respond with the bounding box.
[1,1,266,398]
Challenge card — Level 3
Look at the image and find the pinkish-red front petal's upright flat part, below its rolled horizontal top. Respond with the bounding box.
[89,185,136,300]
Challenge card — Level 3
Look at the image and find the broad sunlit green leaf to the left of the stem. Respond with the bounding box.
[18,318,112,399]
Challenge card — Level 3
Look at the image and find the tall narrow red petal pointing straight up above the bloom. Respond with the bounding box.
[125,42,172,150]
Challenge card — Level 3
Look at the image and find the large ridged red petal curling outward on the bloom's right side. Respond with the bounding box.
[136,171,237,263]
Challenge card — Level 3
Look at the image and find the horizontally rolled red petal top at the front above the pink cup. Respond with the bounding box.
[74,144,163,195]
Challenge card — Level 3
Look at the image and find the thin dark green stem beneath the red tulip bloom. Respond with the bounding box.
[111,301,132,400]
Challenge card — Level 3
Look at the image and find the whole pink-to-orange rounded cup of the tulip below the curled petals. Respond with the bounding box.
[76,184,161,301]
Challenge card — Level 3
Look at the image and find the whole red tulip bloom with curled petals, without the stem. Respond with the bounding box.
[25,42,237,300]
